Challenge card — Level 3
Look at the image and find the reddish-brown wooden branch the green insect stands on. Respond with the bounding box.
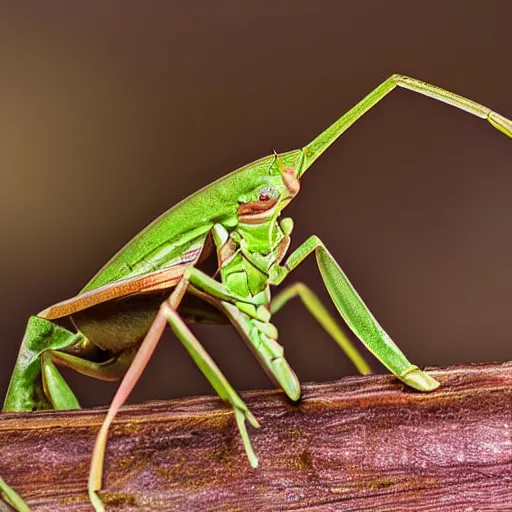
[0,363,512,512]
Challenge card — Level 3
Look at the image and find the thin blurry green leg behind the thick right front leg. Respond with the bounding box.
[270,283,372,375]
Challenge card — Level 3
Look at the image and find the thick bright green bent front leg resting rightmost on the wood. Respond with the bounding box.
[270,236,439,391]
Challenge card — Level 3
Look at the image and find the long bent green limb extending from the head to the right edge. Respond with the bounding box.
[301,74,512,174]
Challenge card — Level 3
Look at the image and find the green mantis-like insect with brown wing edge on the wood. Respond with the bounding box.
[3,75,512,511]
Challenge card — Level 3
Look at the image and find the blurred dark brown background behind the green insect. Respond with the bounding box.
[0,0,512,405]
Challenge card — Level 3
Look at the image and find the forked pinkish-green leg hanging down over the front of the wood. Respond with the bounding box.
[88,281,259,511]
